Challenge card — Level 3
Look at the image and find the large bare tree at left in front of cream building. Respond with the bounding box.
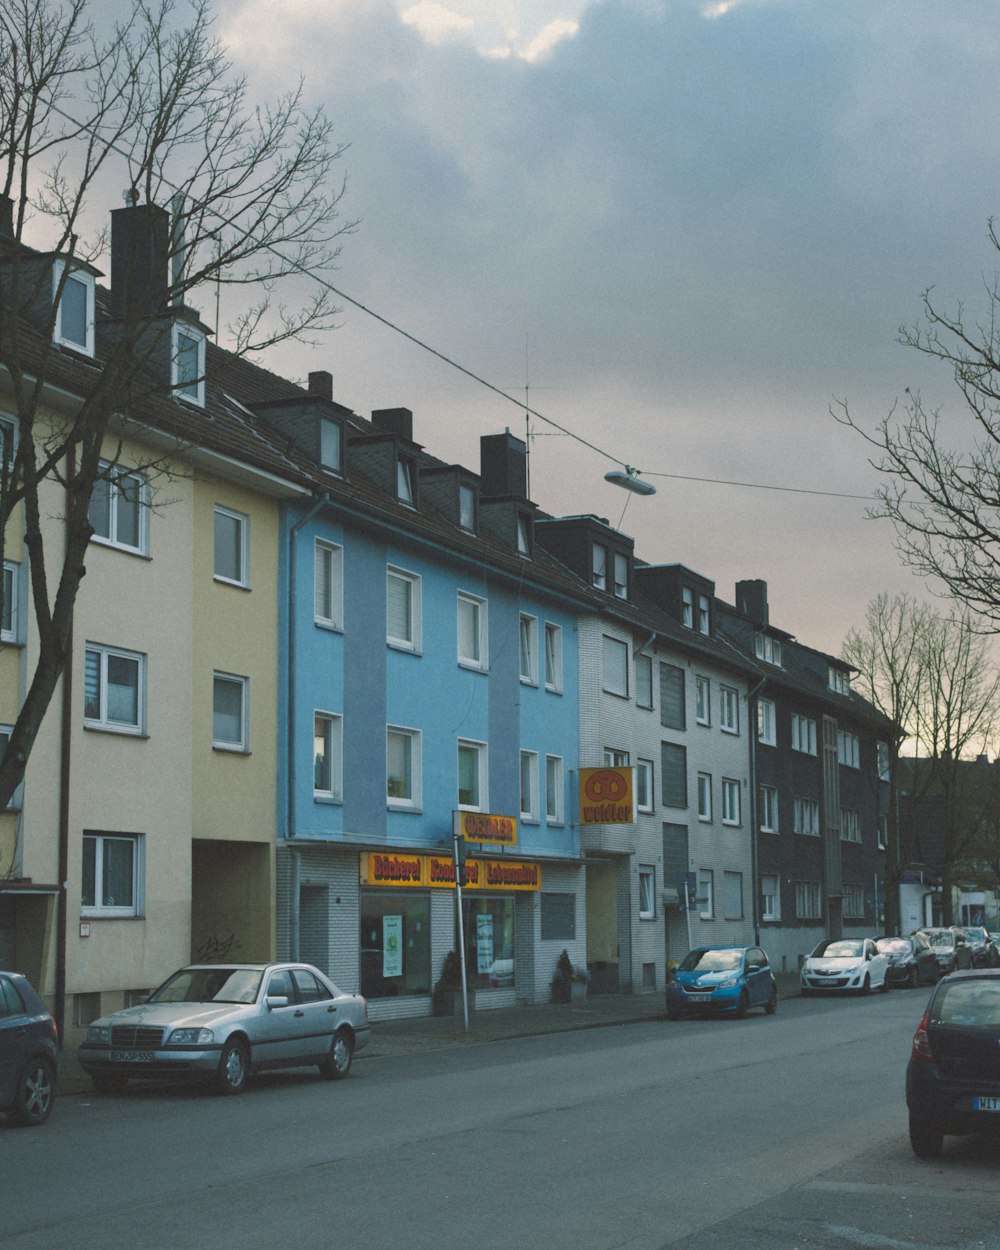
[0,0,354,840]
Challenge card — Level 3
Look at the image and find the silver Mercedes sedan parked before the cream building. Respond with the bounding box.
[78,963,371,1094]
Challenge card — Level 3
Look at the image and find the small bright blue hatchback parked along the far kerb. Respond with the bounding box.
[666,946,778,1020]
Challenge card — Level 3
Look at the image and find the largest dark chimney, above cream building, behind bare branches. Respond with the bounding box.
[111,204,170,320]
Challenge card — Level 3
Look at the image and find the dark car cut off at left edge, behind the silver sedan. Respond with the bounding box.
[0,973,59,1125]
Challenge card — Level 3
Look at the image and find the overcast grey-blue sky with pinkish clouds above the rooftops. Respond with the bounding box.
[219,0,1000,653]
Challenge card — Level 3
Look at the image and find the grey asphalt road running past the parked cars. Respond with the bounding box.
[0,991,1000,1250]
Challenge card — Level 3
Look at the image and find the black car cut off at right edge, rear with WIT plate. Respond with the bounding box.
[906,969,1000,1159]
